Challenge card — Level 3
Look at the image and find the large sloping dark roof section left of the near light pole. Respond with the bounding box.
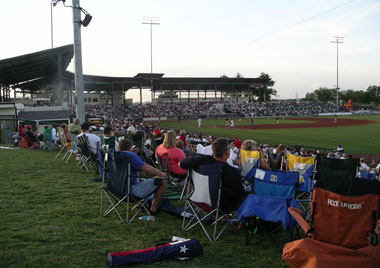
[0,45,74,91]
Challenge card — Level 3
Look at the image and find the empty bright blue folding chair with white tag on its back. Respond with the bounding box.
[236,168,299,245]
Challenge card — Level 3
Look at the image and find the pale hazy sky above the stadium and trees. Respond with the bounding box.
[0,0,380,101]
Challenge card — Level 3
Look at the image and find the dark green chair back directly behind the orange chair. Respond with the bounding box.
[315,154,360,195]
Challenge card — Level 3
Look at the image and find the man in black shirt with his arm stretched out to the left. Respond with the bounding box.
[179,138,247,213]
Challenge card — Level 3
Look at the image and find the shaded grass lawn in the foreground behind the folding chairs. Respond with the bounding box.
[0,149,288,267]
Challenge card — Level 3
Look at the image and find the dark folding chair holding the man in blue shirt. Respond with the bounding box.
[100,150,152,223]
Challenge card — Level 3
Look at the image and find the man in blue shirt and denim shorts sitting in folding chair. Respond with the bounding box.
[118,139,167,214]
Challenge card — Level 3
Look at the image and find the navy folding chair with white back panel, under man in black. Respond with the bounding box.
[182,163,229,242]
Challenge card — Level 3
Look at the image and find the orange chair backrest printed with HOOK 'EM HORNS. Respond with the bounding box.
[311,187,380,249]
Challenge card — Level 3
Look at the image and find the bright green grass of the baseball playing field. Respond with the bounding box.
[157,115,380,154]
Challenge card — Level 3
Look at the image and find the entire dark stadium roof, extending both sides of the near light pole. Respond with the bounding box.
[0,45,268,95]
